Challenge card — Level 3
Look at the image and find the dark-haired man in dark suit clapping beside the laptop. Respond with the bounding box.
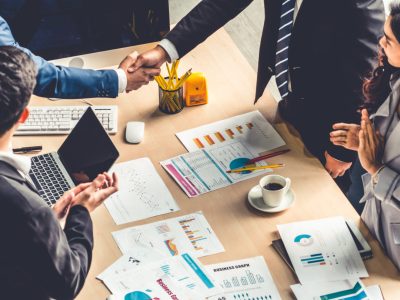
[0,46,118,300]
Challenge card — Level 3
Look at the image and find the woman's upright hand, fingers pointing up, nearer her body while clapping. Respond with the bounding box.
[358,109,384,175]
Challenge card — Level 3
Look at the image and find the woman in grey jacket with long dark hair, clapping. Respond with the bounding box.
[331,1,400,269]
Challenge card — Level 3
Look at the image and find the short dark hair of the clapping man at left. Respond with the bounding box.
[0,46,36,136]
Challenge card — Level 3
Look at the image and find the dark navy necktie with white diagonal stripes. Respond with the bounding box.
[275,0,296,99]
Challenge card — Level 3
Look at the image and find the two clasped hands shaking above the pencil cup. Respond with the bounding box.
[118,46,169,93]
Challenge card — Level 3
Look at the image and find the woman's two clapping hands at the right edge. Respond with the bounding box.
[330,109,384,175]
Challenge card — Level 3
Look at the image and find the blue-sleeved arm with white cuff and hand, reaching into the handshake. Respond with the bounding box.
[0,16,160,99]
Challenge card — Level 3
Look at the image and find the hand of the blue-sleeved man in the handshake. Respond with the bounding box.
[119,51,161,93]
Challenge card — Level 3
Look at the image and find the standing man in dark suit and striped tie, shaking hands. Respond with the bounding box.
[130,0,384,191]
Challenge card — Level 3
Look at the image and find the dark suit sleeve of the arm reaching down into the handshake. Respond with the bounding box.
[166,0,252,57]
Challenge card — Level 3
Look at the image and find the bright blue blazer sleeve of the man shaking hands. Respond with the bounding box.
[0,17,118,99]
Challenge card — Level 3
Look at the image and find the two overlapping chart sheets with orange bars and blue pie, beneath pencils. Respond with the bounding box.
[160,111,285,197]
